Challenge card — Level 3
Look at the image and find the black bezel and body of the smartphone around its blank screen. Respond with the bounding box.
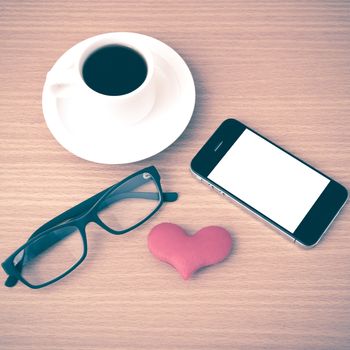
[191,118,348,247]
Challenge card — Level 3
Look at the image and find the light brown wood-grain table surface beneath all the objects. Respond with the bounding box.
[0,0,350,350]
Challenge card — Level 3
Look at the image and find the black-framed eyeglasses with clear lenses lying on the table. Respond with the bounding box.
[2,166,178,288]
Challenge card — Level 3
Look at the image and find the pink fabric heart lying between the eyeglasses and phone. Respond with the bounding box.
[148,223,232,279]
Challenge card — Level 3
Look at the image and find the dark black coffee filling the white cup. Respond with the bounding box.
[83,45,147,96]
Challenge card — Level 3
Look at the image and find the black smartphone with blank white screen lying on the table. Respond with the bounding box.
[191,119,348,247]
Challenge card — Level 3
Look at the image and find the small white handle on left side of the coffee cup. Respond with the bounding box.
[46,68,79,97]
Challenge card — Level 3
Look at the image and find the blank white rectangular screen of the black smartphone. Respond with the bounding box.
[208,129,329,233]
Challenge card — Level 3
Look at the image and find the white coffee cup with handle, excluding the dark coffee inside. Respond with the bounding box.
[46,33,156,132]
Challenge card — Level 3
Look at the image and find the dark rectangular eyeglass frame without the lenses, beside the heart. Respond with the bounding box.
[1,165,178,289]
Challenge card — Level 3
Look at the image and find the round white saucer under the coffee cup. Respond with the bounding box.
[42,33,195,164]
